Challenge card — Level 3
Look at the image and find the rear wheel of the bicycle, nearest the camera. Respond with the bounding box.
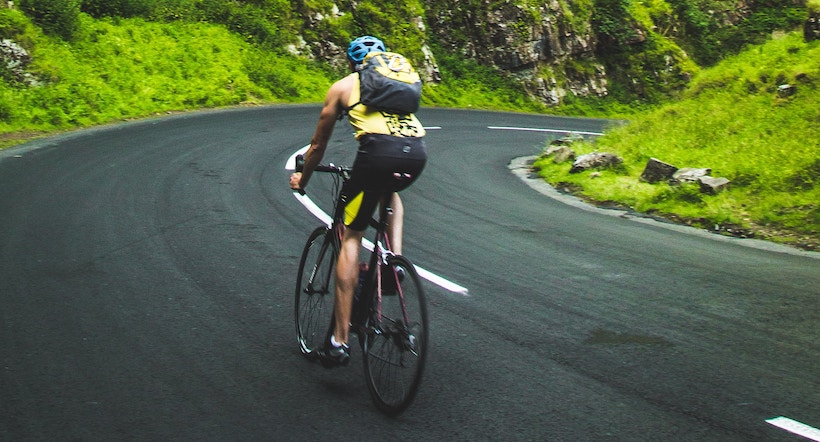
[362,256,429,416]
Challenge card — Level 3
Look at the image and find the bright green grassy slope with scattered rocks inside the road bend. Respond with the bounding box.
[536,33,820,248]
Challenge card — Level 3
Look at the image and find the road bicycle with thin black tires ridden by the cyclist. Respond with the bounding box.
[294,158,428,416]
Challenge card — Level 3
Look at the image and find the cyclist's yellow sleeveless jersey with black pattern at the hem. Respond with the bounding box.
[347,73,426,139]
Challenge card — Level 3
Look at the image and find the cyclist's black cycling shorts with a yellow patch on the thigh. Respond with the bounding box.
[342,134,427,231]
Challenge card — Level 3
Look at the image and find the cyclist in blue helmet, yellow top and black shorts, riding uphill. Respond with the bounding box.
[290,36,427,367]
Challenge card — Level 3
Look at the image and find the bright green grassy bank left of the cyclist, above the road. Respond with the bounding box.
[0,10,331,144]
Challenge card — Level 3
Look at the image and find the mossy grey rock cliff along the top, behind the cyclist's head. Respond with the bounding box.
[287,0,788,106]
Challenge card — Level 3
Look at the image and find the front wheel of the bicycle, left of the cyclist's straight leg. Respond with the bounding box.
[294,227,339,359]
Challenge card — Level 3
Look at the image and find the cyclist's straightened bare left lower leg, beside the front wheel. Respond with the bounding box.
[333,228,364,344]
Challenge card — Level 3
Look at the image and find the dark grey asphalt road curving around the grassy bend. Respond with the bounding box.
[0,106,820,441]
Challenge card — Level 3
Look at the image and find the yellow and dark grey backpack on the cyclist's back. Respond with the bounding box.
[350,52,421,115]
